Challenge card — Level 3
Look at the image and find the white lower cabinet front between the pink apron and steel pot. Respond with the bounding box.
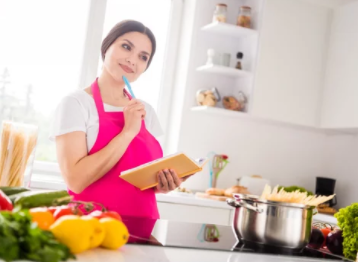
[158,202,231,226]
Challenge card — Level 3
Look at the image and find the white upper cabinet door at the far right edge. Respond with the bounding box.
[322,1,358,127]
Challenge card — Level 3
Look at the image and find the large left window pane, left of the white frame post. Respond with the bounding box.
[0,0,90,162]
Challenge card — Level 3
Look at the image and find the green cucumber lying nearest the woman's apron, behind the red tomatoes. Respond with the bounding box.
[14,190,71,208]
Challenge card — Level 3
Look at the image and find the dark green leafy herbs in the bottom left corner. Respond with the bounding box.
[0,210,75,262]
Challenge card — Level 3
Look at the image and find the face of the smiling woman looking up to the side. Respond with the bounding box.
[104,32,152,82]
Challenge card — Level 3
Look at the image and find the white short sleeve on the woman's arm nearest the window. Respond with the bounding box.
[49,96,86,141]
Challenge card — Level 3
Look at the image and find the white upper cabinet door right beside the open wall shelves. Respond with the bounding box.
[253,0,332,126]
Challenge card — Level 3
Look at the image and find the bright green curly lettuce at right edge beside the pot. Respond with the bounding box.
[334,203,358,260]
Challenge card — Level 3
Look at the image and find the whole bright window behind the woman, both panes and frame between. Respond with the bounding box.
[0,0,179,185]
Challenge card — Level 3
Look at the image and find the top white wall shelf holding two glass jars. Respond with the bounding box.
[201,22,258,38]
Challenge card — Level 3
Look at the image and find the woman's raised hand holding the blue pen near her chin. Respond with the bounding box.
[123,99,146,139]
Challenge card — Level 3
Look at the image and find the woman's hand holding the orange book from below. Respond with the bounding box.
[156,169,192,193]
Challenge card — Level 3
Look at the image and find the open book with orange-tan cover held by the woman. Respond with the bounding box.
[120,153,208,190]
